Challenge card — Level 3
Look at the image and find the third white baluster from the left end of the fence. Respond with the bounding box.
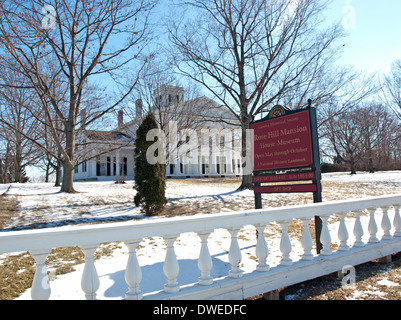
[125,240,143,300]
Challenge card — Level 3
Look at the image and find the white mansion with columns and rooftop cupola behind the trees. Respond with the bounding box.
[74,85,241,181]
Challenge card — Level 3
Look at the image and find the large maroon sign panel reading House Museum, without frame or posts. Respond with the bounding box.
[251,110,313,171]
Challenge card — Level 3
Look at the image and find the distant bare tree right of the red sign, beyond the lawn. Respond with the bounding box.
[321,101,401,174]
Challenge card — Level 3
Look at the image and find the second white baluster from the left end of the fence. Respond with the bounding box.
[81,245,100,300]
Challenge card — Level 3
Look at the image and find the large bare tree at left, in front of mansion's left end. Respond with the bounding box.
[0,0,155,192]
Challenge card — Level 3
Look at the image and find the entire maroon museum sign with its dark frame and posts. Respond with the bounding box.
[250,100,322,253]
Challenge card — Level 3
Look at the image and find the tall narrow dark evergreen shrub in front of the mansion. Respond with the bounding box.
[134,113,167,216]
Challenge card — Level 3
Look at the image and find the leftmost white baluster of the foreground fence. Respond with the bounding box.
[30,250,51,300]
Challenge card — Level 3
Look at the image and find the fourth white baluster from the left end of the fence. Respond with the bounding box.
[163,236,180,293]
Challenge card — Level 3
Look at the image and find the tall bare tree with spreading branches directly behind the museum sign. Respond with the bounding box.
[169,0,360,188]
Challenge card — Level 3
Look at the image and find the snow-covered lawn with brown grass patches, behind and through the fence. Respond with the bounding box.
[0,171,401,299]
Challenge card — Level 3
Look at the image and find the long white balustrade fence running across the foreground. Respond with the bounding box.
[0,196,401,300]
